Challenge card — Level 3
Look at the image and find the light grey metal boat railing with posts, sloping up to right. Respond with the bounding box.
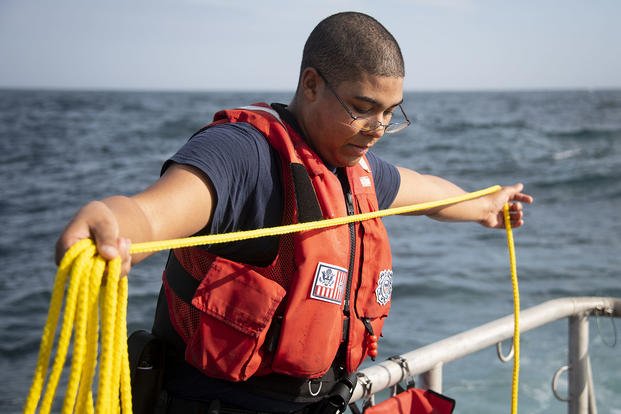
[350,297,621,414]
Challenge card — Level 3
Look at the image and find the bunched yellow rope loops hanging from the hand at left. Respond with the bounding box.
[24,239,132,414]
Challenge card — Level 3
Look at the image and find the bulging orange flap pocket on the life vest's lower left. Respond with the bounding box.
[185,258,286,381]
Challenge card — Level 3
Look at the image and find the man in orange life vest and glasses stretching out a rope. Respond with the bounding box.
[56,12,533,413]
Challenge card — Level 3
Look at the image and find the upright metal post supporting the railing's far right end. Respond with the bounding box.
[568,313,589,414]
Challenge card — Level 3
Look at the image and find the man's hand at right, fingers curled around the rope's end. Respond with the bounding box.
[480,183,534,229]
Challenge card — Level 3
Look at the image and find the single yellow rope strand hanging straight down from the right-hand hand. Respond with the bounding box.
[503,204,520,414]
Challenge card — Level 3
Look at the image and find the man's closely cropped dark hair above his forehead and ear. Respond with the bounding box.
[300,12,405,85]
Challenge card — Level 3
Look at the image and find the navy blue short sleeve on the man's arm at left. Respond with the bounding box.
[162,122,282,238]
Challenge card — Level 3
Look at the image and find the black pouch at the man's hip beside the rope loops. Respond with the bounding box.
[127,330,165,414]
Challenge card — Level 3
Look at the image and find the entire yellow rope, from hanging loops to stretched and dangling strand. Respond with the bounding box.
[24,186,519,414]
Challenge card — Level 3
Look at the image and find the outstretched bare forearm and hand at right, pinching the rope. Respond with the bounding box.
[392,167,533,228]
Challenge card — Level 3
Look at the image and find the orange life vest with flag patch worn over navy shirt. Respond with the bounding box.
[163,104,392,381]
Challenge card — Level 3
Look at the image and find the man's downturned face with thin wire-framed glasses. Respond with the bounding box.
[299,68,403,167]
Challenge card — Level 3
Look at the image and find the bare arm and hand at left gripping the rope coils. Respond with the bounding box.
[56,164,215,274]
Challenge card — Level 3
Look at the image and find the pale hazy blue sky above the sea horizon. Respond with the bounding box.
[0,0,621,91]
